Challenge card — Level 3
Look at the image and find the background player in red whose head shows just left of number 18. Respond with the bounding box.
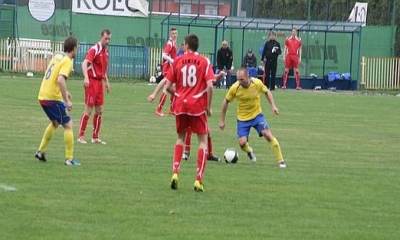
[156,28,178,117]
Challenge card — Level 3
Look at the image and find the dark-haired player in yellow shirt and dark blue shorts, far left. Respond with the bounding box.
[35,37,80,165]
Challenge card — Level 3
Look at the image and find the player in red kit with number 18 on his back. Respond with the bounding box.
[166,34,215,192]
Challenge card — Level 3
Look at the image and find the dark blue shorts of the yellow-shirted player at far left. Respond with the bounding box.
[39,100,71,125]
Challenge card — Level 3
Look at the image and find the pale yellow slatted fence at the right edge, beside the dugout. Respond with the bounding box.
[360,57,400,90]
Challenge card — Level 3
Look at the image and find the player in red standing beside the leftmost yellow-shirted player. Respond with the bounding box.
[78,29,111,144]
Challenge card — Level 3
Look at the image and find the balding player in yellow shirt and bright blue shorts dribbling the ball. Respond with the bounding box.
[219,68,286,168]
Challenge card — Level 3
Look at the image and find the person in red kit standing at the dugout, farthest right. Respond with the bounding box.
[282,28,301,90]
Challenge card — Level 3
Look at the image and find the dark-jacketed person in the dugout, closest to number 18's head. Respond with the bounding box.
[217,40,233,88]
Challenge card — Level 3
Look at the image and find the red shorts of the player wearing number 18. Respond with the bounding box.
[175,114,208,134]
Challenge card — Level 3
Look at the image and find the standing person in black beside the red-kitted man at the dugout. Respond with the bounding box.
[262,31,282,90]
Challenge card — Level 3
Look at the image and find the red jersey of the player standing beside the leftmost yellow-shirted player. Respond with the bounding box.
[86,43,108,80]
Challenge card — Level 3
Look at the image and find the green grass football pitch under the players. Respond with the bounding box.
[0,76,400,240]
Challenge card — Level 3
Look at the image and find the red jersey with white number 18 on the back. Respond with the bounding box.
[166,52,214,116]
